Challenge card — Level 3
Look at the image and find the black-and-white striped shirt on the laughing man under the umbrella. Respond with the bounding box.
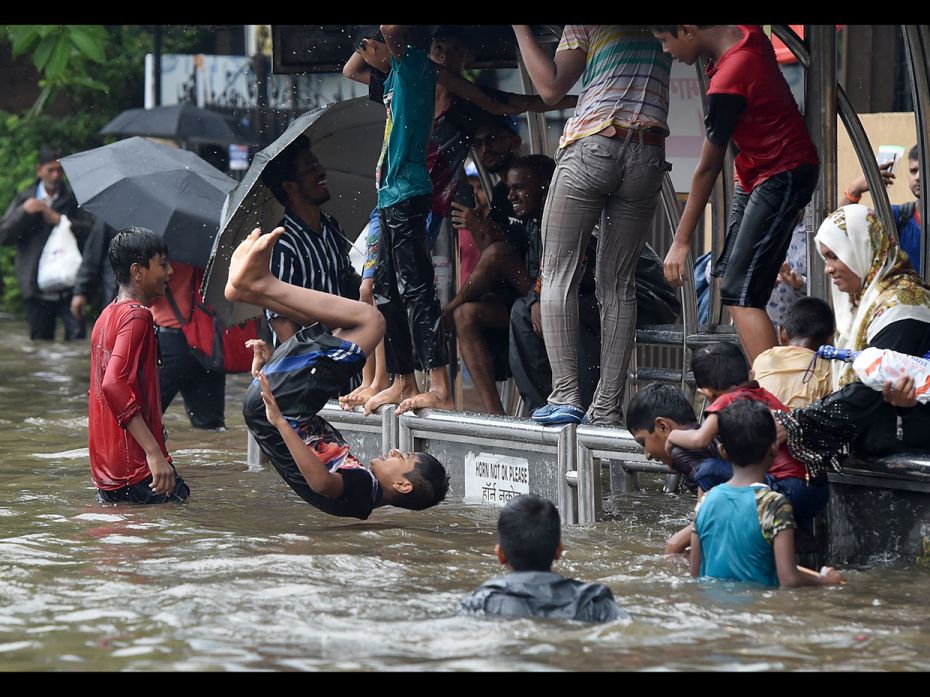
[265,210,358,336]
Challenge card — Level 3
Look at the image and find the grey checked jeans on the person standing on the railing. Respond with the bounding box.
[540,135,668,424]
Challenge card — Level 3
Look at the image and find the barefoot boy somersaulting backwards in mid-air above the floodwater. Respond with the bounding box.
[225,227,449,520]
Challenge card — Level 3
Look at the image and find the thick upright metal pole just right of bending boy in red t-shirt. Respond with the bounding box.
[804,24,836,300]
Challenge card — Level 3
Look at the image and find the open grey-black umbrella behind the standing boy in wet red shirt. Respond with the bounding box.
[61,138,236,268]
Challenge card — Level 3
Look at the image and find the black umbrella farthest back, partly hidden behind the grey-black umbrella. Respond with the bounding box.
[100,104,243,144]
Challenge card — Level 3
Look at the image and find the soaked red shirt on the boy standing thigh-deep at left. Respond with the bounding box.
[87,300,171,491]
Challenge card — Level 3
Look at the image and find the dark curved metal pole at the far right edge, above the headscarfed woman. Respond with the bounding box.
[901,24,930,280]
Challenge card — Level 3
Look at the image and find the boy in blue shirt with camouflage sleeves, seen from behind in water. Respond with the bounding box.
[691,400,845,588]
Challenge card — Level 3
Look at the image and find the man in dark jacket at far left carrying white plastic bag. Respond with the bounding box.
[0,147,91,341]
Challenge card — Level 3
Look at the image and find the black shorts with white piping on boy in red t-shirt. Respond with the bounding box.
[712,164,819,309]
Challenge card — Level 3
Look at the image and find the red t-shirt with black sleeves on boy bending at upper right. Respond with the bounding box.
[707,24,820,192]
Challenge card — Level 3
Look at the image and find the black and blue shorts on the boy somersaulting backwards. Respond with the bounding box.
[242,324,365,476]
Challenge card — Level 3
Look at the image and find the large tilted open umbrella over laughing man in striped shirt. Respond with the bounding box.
[204,97,385,324]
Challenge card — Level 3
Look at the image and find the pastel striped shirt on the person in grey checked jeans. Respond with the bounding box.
[556,24,672,148]
